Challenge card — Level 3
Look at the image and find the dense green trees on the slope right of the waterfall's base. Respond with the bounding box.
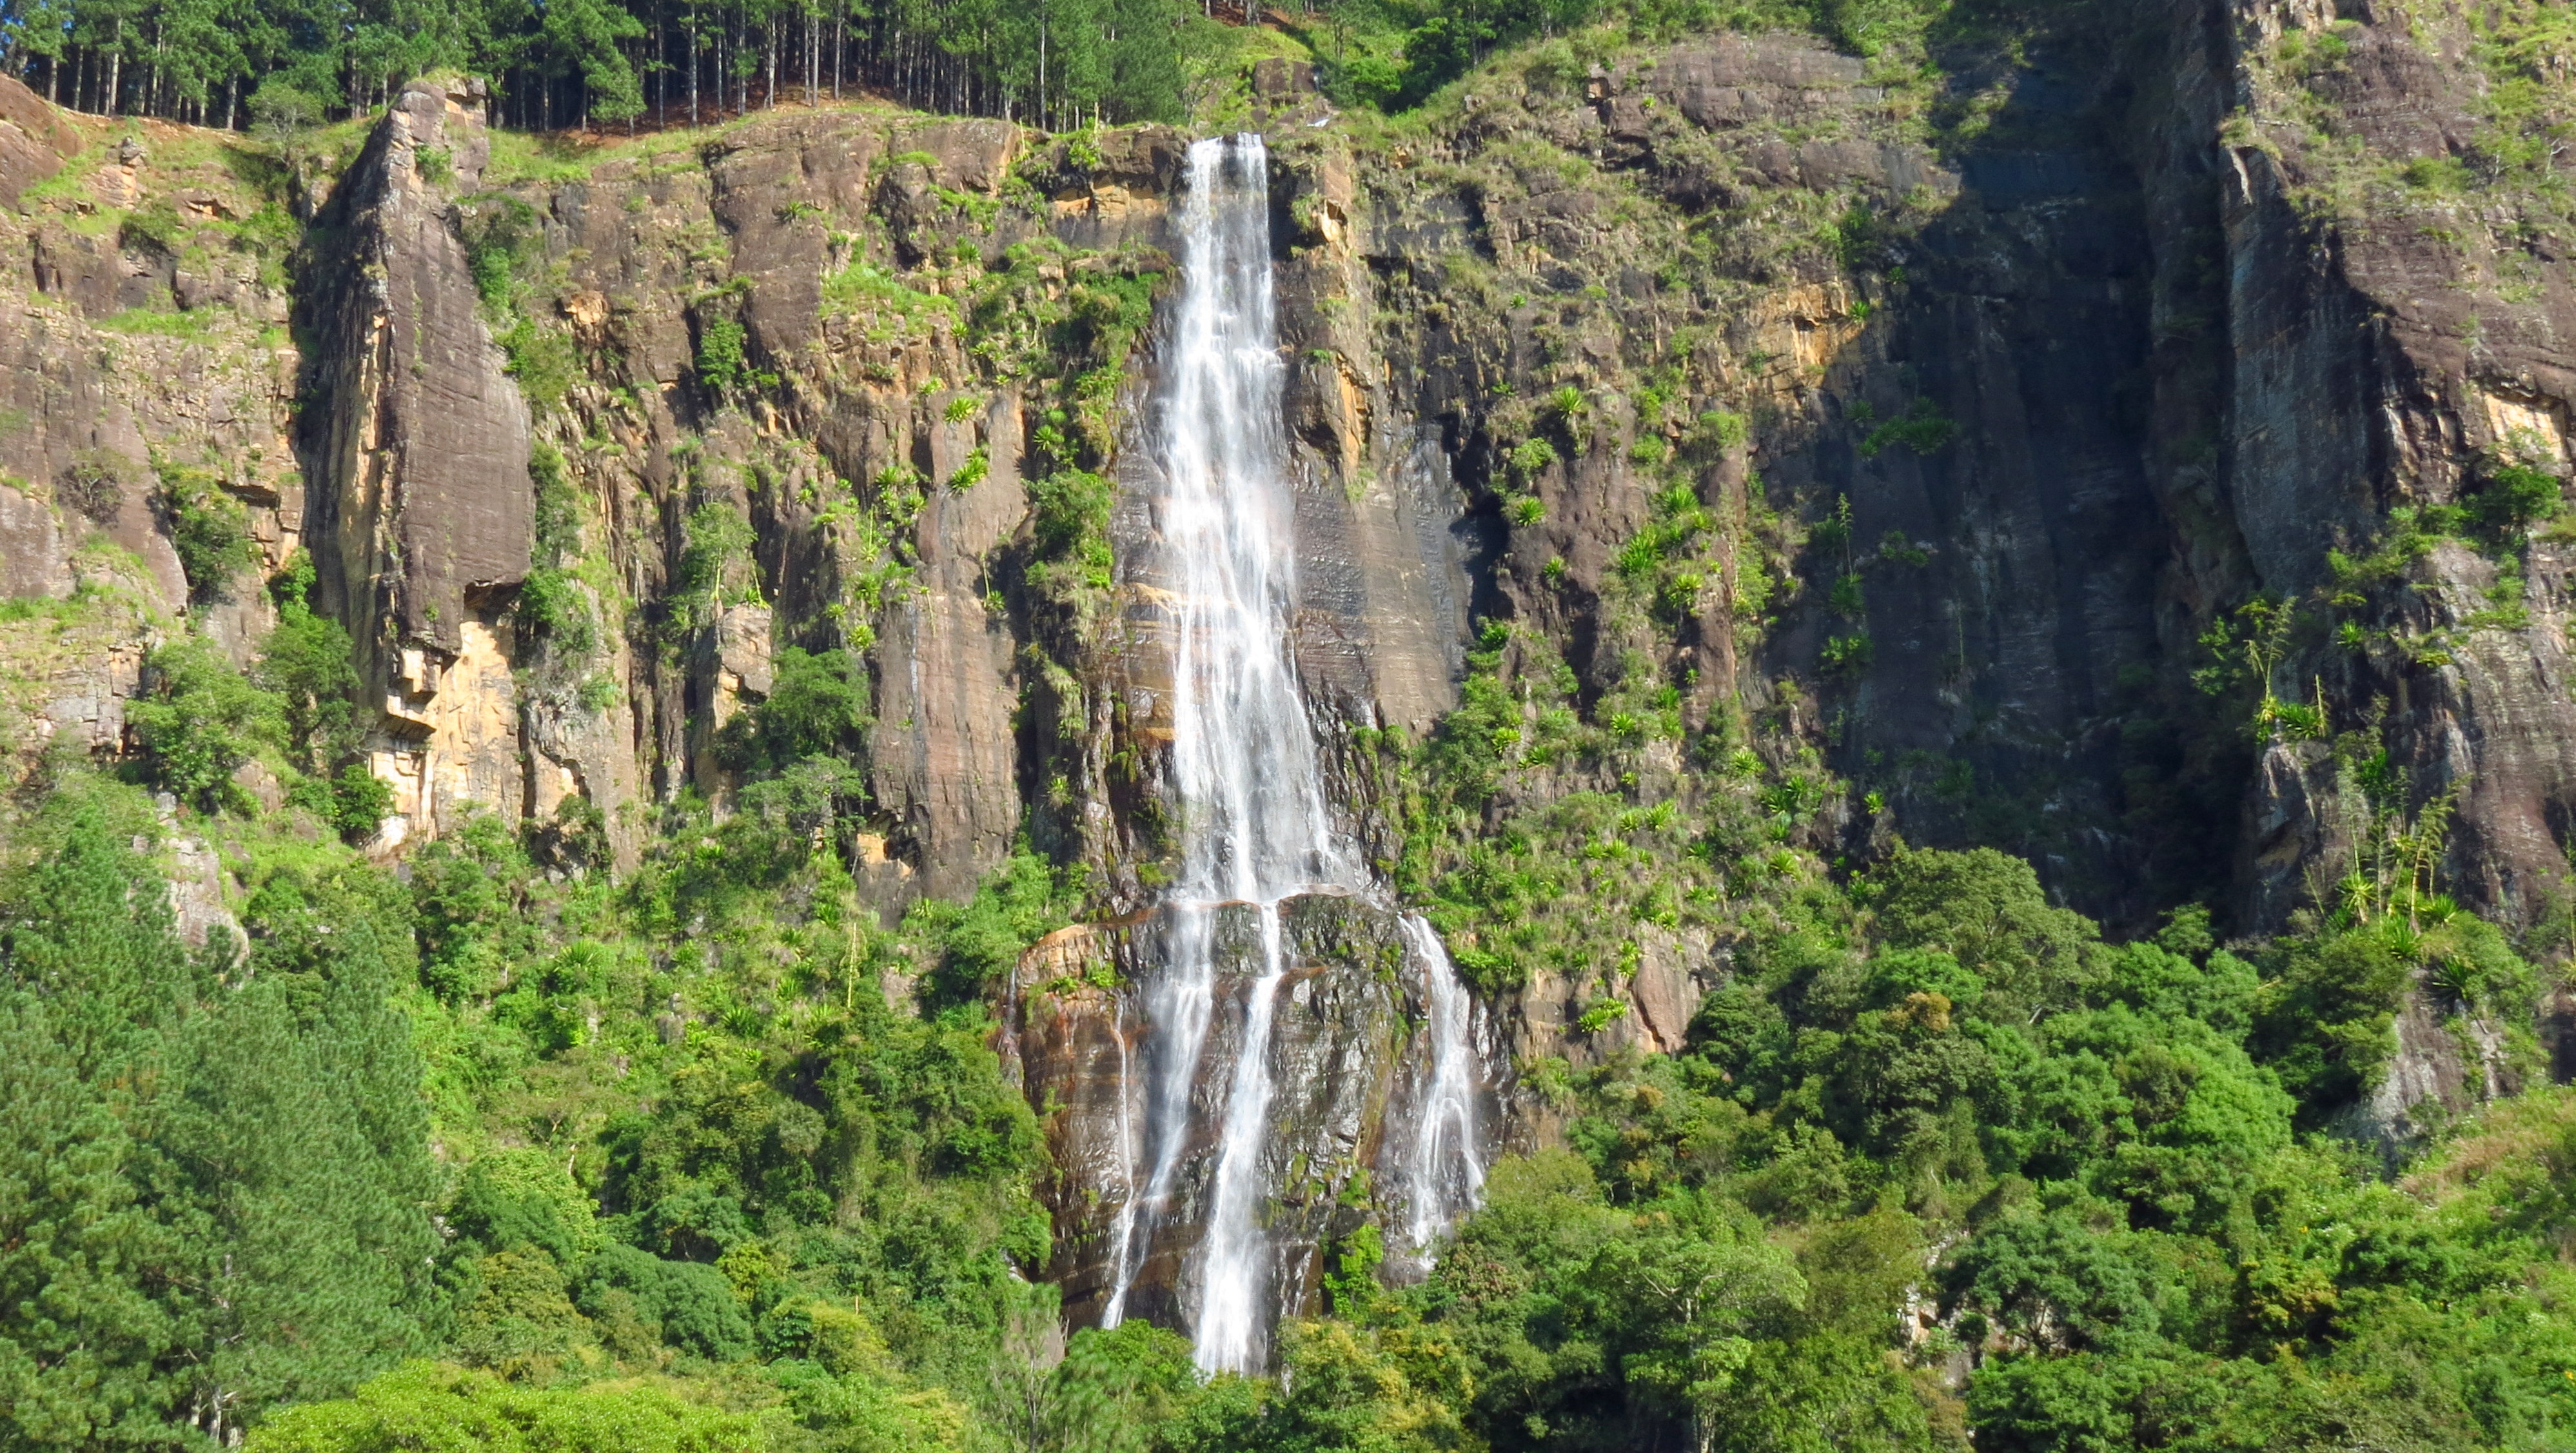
[1172,850,2576,1450]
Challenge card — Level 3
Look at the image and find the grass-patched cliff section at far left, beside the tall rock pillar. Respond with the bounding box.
[0,83,306,762]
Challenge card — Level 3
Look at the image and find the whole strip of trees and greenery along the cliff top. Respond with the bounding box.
[0,0,1955,129]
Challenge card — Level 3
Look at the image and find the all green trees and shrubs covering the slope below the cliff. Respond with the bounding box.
[20,685,2576,1453]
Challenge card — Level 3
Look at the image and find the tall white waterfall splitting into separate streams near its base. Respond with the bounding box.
[1103,134,1481,1370]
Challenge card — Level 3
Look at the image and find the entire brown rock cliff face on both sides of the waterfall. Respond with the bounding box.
[0,0,2576,1306]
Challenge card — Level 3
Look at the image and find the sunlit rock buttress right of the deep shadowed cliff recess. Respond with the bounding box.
[2208,5,2576,943]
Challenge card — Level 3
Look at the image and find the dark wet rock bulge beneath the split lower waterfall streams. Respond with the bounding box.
[1005,894,1491,1327]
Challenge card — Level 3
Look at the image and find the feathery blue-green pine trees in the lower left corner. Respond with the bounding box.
[0,788,438,1448]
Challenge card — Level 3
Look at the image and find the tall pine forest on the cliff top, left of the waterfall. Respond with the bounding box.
[0,0,1190,133]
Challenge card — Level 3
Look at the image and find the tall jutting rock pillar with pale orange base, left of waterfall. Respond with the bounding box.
[296,85,538,842]
